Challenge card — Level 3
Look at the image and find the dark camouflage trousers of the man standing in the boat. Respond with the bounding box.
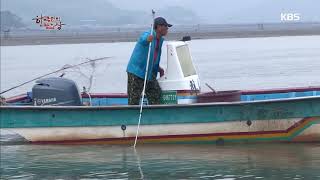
[127,73,161,105]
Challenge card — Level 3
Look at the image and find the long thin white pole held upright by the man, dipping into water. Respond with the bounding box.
[133,10,155,148]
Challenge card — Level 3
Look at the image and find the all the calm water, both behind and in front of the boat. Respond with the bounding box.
[0,36,320,180]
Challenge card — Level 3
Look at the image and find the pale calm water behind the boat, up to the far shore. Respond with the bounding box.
[0,36,320,96]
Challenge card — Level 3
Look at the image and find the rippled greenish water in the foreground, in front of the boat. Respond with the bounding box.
[1,144,320,179]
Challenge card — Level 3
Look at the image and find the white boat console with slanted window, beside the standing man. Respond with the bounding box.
[158,41,200,104]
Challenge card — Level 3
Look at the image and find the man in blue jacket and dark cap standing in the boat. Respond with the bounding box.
[127,17,172,105]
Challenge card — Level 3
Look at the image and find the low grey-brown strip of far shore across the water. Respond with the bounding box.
[0,28,320,46]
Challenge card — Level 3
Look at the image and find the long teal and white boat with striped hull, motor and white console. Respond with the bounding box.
[0,41,320,144]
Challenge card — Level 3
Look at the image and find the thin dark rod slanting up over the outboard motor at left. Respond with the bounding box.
[0,57,110,94]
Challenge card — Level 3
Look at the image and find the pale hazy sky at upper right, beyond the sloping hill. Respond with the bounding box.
[109,0,320,24]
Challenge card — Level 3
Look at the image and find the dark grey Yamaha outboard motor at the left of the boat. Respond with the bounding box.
[32,77,82,106]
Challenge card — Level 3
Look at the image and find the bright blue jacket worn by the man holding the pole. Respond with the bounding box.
[127,31,164,80]
